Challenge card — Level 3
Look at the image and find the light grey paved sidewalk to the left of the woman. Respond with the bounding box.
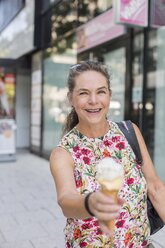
[0,152,65,248]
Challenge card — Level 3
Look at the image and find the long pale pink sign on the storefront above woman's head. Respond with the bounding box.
[77,9,126,53]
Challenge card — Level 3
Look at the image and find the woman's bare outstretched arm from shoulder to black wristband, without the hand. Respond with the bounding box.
[50,147,89,219]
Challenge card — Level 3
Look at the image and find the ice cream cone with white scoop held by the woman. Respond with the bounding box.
[98,158,123,231]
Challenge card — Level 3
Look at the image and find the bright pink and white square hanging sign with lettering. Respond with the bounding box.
[114,0,148,27]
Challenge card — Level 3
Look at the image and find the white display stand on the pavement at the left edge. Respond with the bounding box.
[0,119,16,162]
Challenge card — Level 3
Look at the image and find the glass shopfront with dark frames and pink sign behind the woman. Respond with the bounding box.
[39,0,165,178]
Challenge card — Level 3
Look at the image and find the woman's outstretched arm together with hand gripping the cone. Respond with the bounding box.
[50,147,123,232]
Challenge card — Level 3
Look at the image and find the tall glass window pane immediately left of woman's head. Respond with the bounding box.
[43,35,76,154]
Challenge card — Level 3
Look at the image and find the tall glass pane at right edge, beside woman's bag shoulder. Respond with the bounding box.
[148,28,165,181]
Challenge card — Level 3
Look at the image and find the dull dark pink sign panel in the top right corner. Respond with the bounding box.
[150,0,165,27]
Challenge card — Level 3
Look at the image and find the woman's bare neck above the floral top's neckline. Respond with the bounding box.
[76,120,109,138]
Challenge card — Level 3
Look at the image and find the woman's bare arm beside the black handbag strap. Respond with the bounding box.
[133,124,165,222]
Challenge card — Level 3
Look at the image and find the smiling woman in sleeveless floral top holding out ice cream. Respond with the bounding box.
[50,61,165,248]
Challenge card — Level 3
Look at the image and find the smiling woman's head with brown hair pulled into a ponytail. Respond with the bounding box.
[64,61,111,136]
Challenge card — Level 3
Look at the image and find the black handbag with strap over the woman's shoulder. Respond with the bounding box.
[116,120,164,234]
